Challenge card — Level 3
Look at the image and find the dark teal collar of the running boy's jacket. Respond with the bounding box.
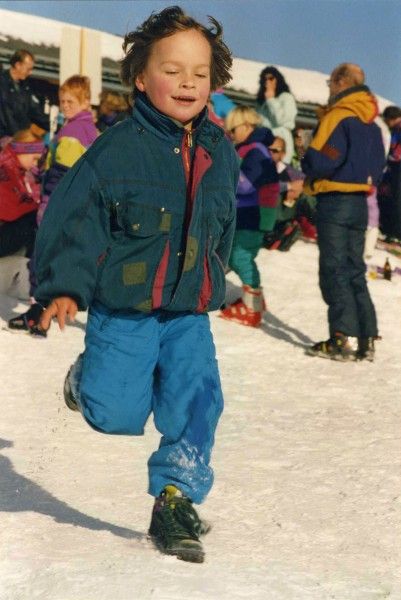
[132,92,224,153]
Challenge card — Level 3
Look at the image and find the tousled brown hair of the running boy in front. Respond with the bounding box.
[121,6,232,98]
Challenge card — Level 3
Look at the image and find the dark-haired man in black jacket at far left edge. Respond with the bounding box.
[0,50,49,138]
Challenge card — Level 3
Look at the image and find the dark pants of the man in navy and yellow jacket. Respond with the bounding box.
[316,193,378,337]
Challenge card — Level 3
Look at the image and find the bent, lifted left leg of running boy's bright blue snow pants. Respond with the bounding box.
[78,304,159,435]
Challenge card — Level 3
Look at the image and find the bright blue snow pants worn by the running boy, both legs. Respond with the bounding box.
[70,304,223,503]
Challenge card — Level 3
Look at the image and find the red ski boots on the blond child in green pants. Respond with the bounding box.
[219,285,266,327]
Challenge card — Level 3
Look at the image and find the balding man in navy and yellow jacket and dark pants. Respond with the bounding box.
[302,63,385,360]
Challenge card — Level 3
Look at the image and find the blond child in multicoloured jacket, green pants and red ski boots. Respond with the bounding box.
[220,106,279,327]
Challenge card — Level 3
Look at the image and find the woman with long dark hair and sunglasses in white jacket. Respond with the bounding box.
[256,66,297,163]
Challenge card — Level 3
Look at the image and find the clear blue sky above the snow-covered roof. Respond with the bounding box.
[0,0,401,106]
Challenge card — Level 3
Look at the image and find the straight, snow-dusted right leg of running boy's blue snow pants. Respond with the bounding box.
[148,313,223,503]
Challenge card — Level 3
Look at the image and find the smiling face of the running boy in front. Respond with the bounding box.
[135,29,211,125]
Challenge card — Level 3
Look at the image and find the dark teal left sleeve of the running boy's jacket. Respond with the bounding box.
[35,156,110,310]
